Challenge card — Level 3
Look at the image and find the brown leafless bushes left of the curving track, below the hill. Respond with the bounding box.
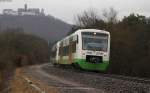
[0,28,49,93]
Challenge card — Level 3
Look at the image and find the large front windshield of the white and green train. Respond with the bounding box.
[82,32,108,51]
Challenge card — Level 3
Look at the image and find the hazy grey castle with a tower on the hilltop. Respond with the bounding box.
[3,4,45,16]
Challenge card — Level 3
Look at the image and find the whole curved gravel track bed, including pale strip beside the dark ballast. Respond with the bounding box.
[26,64,150,93]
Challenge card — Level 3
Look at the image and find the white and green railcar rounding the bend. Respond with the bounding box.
[51,29,110,71]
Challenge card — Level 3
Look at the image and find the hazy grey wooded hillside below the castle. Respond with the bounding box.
[0,15,71,42]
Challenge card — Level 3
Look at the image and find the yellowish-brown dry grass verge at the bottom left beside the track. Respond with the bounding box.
[11,69,56,93]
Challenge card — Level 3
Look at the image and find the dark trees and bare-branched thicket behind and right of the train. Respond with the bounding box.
[68,8,150,78]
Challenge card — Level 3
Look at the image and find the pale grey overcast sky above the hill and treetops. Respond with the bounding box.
[0,0,150,23]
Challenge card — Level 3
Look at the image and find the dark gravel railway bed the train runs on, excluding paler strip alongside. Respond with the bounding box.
[38,64,150,93]
